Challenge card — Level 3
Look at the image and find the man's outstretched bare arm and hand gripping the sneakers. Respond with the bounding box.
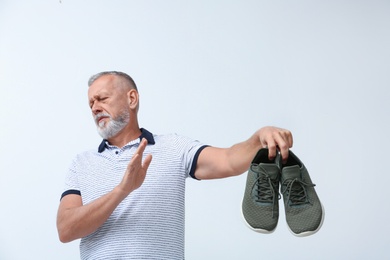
[195,127,293,179]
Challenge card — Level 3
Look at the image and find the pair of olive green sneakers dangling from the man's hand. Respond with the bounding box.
[242,148,324,237]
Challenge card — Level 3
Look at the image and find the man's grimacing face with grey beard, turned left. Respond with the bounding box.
[88,75,130,139]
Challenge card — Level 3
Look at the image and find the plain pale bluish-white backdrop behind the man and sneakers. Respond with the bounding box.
[0,0,390,260]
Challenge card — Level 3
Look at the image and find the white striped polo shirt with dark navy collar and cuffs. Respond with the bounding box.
[62,129,206,260]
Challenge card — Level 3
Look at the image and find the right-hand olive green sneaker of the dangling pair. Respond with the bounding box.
[279,151,325,237]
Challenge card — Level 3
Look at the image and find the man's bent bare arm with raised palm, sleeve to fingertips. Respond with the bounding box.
[57,139,152,243]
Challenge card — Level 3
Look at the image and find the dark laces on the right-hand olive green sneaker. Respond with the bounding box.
[282,178,316,206]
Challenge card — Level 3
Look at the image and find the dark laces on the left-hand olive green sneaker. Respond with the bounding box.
[252,167,280,217]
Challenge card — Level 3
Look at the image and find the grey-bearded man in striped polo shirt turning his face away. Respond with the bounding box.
[57,71,293,260]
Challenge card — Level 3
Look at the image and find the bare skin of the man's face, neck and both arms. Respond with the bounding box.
[57,75,293,242]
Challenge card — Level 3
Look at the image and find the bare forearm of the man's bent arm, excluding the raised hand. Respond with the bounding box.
[57,188,126,242]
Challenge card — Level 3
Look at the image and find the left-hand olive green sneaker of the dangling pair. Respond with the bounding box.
[241,149,280,234]
